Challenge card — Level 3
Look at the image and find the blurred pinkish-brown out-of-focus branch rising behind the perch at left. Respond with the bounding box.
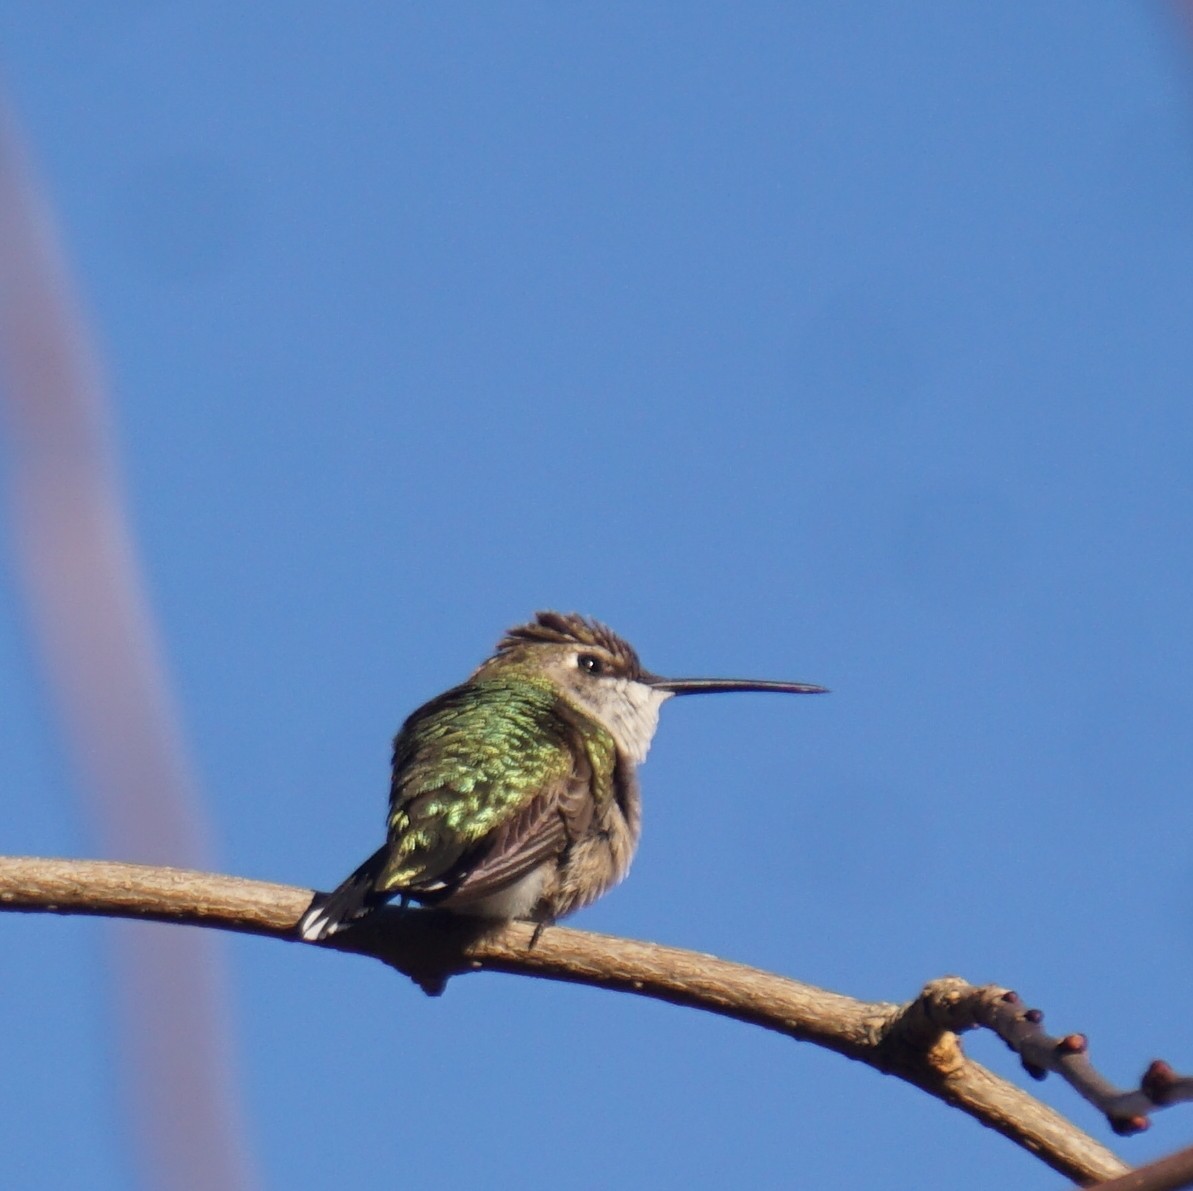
[0,98,255,1191]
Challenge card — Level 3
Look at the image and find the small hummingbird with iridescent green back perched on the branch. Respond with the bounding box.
[298,612,824,942]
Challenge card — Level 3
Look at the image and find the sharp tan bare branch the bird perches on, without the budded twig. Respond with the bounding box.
[0,857,1129,1185]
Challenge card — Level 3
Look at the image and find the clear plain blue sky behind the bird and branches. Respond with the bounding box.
[0,0,1193,1191]
